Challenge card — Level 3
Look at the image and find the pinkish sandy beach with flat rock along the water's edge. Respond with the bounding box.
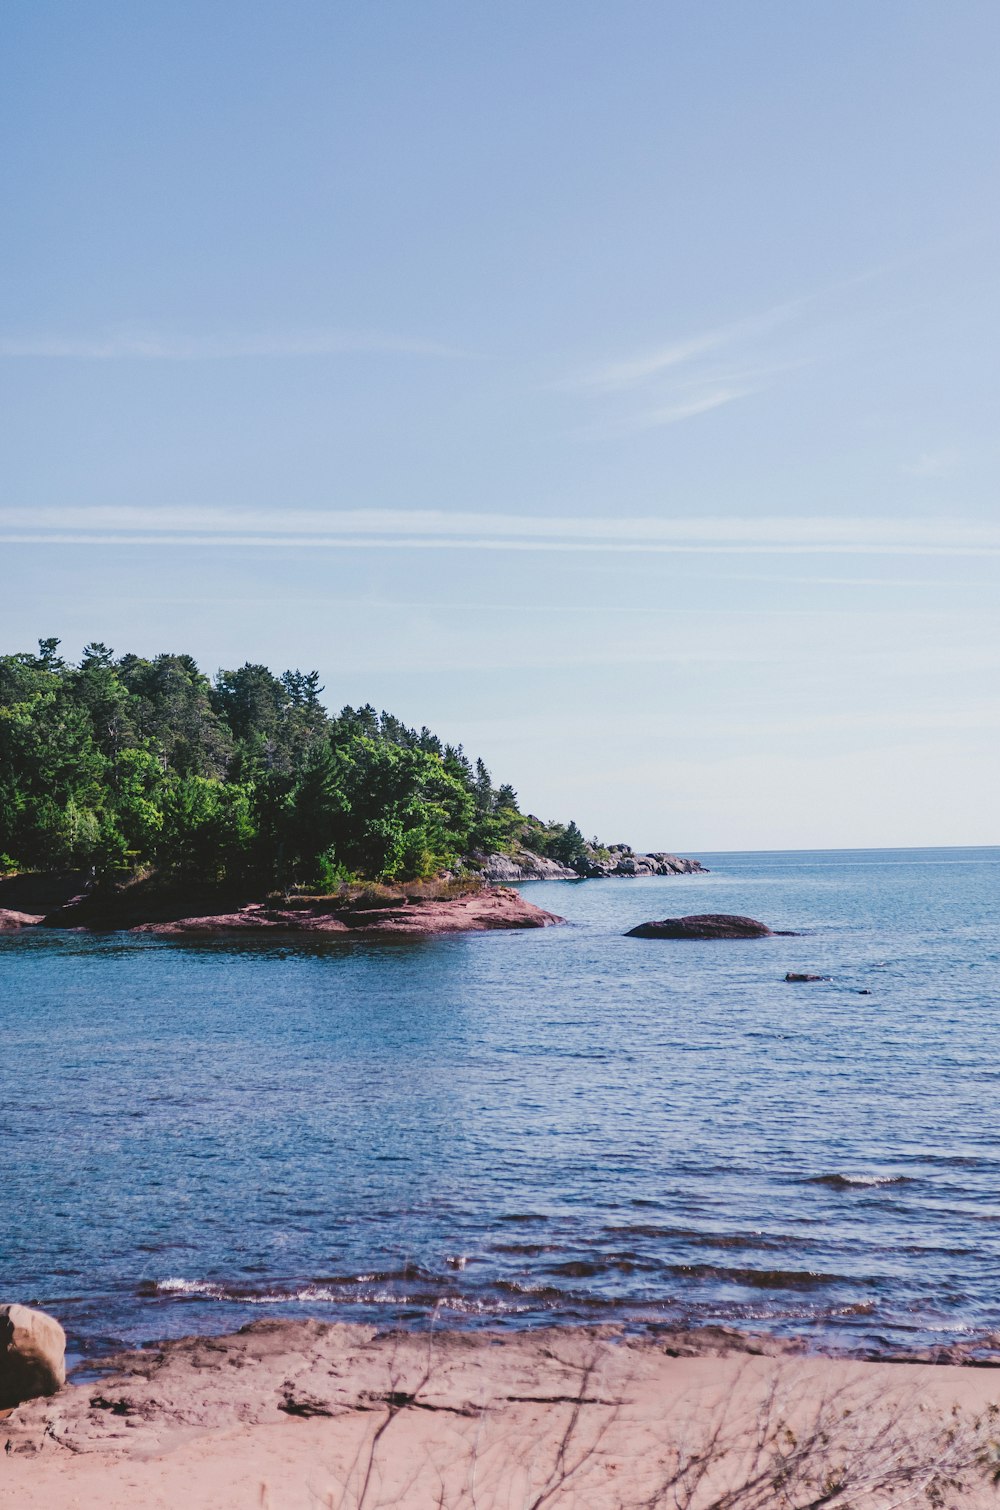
[0,1321,1000,1510]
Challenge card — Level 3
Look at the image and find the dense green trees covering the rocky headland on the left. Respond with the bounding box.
[0,639,598,886]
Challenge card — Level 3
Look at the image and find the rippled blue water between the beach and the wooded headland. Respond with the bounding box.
[0,849,1000,1351]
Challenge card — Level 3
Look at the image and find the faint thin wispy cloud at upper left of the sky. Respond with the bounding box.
[0,329,468,362]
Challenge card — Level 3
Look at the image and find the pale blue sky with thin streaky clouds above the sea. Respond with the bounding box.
[0,0,1000,853]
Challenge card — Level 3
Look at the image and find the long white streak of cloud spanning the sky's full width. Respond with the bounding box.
[7,506,1000,556]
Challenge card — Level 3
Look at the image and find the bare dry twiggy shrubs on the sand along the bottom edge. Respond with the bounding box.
[315,1351,1000,1510]
